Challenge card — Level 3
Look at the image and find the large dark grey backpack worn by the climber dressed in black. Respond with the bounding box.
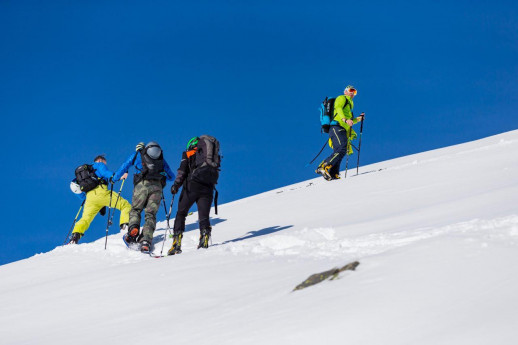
[190,135,221,185]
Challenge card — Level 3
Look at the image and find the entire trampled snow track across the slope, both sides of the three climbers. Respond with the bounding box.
[43,215,518,266]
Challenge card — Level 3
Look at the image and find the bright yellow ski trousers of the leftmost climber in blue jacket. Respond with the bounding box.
[72,185,131,234]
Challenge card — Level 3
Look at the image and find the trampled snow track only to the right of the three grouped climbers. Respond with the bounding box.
[218,215,518,259]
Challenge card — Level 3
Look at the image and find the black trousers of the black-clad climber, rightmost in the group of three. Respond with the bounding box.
[173,181,214,235]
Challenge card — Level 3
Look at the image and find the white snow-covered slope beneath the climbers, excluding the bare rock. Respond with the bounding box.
[0,131,518,345]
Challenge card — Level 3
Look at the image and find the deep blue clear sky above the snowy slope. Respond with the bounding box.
[0,1,518,264]
